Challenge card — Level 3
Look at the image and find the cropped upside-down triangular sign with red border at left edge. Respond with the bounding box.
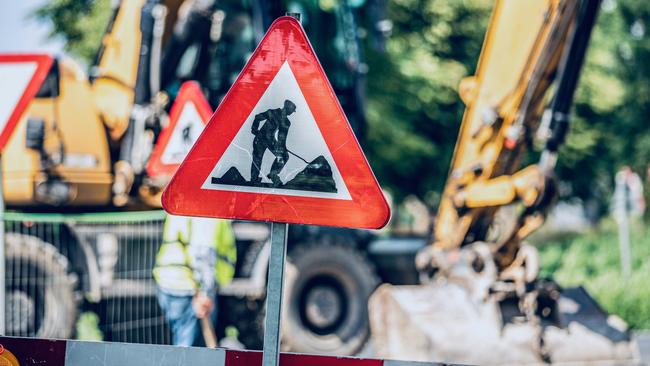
[0,54,53,151]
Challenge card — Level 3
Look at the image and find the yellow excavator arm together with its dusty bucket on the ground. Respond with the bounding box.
[369,0,639,365]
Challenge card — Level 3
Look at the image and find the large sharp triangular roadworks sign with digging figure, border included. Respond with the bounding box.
[162,17,390,228]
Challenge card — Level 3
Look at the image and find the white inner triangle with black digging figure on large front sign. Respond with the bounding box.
[201,62,351,200]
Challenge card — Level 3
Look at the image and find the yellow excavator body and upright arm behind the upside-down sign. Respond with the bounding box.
[2,1,158,207]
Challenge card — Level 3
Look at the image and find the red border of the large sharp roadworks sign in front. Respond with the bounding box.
[162,17,390,229]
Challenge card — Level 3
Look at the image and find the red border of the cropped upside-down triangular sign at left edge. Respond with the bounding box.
[0,54,54,151]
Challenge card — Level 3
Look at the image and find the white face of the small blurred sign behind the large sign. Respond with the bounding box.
[160,101,205,165]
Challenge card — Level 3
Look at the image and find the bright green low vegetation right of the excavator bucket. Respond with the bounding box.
[532,220,650,329]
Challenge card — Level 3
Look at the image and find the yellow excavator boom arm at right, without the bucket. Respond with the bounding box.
[433,0,579,266]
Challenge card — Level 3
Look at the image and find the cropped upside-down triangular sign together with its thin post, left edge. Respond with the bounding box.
[0,54,54,335]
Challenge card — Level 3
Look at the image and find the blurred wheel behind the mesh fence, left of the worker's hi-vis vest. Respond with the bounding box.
[5,233,78,338]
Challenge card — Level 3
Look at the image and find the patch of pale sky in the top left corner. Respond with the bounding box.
[0,0,63,54]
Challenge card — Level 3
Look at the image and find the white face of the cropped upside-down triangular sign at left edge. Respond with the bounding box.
[0,62,38,131]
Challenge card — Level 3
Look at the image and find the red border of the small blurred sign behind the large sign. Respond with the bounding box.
[147,81,212,177]
